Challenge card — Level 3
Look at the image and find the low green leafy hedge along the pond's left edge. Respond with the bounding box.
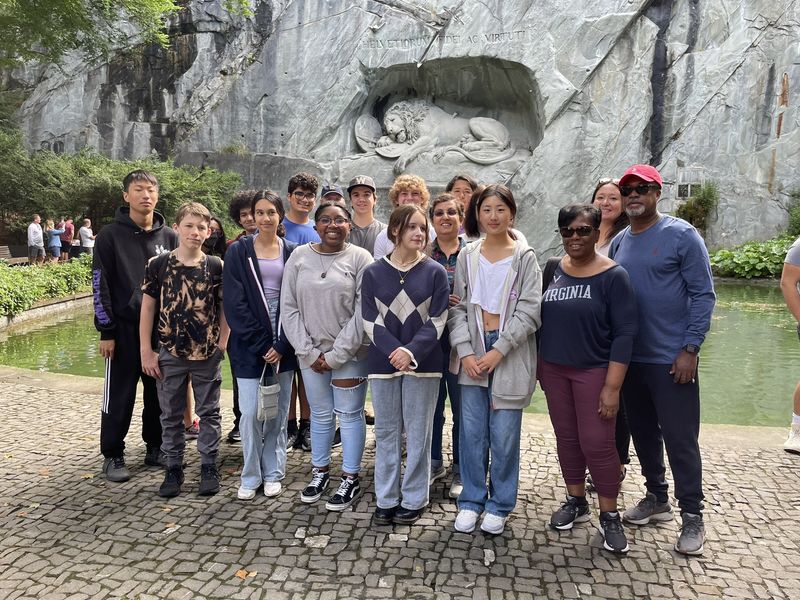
[0,254,92,316]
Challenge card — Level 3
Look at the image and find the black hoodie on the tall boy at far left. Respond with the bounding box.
[92,206,178,340]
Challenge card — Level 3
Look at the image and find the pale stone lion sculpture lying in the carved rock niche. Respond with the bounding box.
[375,100,516,174]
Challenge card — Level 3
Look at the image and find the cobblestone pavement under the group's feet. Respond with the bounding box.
[0,368,800,600]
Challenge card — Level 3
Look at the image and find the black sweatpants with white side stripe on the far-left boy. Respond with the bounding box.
[100,321,161,458]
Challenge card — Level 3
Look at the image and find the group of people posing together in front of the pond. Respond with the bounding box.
[93,165,715,555]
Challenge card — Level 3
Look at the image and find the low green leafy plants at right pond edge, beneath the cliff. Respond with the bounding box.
[711,235,795,279]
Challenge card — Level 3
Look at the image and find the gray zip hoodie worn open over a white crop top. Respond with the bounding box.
[447,240,542,409]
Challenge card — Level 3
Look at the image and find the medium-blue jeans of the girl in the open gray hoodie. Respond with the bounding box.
[458,331,522,517]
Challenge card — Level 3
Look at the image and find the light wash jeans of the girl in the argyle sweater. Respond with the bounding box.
[370,375,441,510]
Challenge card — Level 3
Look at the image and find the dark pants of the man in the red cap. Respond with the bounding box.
[622,362,703,514]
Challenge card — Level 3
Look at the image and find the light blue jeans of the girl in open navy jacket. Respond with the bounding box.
[236,371,294,490]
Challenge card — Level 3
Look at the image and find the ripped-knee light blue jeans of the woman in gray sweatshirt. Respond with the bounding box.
[302,361,367,475]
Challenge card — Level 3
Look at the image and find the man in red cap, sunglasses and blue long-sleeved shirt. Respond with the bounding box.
[609,165,716,555]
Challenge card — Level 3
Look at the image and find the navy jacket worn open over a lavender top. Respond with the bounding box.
[222,236,297,379]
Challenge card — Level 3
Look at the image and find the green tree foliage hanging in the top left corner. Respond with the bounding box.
[0,0,180,67]
